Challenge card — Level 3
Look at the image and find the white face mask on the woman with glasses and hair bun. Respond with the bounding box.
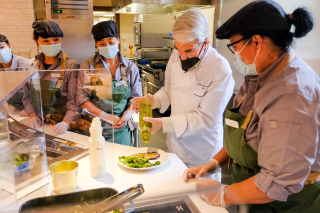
[233,38,260,75]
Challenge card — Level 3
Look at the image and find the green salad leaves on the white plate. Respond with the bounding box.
[119,156,160,168]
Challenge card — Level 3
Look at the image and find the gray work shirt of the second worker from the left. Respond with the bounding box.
[22,51,80,121]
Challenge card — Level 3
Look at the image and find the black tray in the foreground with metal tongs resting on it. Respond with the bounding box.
[19,188,118,213]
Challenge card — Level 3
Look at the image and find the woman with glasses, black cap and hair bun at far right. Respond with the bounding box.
[183,0,320,213]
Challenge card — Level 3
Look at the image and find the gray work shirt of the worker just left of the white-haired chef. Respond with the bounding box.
[77,51,142,106]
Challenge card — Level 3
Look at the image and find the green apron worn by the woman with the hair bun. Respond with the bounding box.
[224,54,320,213]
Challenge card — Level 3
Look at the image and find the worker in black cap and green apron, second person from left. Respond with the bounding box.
[23,20,80,135]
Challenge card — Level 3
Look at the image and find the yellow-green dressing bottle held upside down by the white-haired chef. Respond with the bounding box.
[139,99,152,143]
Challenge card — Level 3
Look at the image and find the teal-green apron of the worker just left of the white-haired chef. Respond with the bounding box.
[90,61,132,146]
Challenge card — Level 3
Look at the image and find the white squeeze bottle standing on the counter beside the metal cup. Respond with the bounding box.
[89,117,106,178]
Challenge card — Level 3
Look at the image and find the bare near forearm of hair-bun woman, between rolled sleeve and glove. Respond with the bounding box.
[225,176,274,205]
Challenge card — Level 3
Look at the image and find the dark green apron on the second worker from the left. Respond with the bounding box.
[30,52,67,123]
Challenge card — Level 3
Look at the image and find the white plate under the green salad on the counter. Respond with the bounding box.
[117,147,169,170]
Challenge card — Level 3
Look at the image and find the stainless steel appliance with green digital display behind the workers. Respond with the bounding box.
[43,0,95,64]
